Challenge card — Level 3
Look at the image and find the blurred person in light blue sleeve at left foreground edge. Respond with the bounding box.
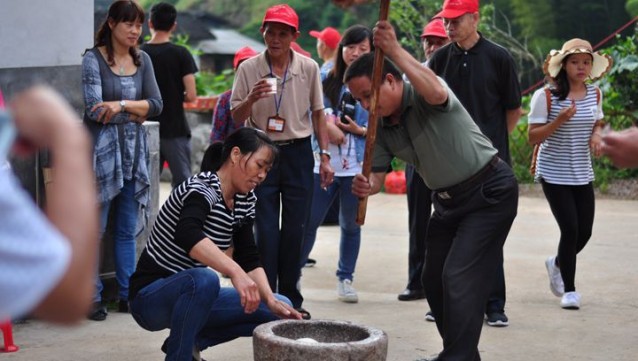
[0,86,99,324]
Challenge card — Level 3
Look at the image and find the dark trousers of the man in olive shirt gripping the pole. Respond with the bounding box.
[423,160,518,361]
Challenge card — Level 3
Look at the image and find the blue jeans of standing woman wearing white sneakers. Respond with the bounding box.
[300,174,361,281]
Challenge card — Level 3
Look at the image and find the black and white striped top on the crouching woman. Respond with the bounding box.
[129,172,260,298]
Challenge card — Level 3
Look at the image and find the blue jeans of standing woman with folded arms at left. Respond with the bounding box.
[93,180,139,302]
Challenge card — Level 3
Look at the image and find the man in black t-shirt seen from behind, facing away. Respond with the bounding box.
[141,3,197,187]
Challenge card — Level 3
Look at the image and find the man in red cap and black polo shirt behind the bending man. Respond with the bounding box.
[428,0,522,327]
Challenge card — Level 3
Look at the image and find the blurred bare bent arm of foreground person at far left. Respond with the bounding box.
[10,87,99,323]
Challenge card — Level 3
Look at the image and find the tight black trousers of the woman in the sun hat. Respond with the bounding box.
[541,181,596,292]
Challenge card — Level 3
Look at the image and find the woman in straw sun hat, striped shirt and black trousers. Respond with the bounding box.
[528,39,612,309]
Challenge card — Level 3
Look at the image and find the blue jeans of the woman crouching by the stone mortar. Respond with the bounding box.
[130,267,290,361]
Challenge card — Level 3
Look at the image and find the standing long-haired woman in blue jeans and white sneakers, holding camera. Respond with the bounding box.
[301,25,373,303]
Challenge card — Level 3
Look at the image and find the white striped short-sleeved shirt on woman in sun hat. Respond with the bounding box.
[528,84,604,185]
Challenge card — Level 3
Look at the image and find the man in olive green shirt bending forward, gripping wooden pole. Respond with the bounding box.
[345,21,518,361]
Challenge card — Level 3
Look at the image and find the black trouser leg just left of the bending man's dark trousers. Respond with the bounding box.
[405,164,432,291]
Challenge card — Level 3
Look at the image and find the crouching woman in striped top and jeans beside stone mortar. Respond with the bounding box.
[129,128,301,361]
